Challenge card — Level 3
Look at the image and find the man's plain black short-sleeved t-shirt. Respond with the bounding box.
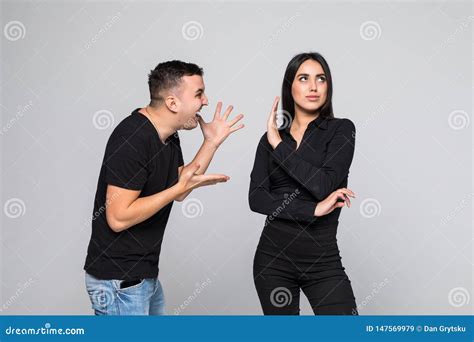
[84,108,183,280]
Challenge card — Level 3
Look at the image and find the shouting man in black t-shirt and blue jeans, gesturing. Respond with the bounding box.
[84,60,244,315]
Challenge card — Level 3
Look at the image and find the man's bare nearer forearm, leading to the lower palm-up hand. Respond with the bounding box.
[113,183,184,232]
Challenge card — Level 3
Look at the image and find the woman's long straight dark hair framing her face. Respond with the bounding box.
[281,52,334,119]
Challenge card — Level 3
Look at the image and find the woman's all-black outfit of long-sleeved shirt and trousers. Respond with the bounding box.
[249,116,358,315]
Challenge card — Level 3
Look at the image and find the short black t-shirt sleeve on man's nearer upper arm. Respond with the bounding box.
[104,132,148,190]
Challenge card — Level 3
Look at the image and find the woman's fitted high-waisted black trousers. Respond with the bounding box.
[253,219,358,315]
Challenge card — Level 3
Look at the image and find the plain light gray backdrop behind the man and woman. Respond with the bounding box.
[0,1,474,315]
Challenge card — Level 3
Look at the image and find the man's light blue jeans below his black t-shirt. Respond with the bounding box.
[85,272,165,315]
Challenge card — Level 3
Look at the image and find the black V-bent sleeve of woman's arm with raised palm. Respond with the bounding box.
[273,119,355,201]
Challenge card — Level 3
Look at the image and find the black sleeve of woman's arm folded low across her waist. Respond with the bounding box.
[248,134,317,222]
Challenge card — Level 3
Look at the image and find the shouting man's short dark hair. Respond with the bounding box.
[148,60,204,106]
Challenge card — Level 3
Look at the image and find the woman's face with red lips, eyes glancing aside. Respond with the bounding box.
[291,59,328,114]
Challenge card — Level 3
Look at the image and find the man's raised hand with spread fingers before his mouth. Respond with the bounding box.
[198,102,244,148]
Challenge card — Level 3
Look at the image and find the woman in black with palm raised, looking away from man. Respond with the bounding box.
[249,53,358,315]
